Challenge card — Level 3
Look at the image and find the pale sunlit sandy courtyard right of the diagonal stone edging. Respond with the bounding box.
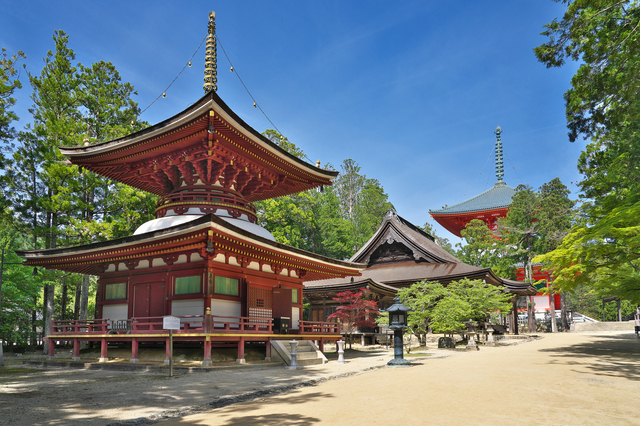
[161,332,640,426]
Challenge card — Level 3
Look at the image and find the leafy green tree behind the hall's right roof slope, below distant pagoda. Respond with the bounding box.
[456,219,516,279]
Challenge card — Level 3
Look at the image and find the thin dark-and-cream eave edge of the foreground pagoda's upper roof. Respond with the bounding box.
[60,91,339,179]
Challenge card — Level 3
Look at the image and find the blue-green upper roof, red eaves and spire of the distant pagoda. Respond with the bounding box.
[429,126,516,237]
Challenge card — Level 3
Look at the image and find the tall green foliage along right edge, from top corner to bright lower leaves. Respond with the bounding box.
[535,0,640,303]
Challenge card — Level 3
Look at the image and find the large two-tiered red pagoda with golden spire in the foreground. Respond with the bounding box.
[18,15,364,365]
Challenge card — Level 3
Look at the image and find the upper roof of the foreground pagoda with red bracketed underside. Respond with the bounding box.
[60,91,338,202]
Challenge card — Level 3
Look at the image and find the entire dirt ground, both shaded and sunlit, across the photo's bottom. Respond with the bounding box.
[0,332,640,426]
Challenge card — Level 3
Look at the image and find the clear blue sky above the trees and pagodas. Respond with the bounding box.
[0,0,585,242]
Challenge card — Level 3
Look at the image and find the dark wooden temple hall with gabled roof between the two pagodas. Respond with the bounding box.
[304,211,536,341]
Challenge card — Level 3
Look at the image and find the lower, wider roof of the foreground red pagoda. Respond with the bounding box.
[16,214,365,281]
